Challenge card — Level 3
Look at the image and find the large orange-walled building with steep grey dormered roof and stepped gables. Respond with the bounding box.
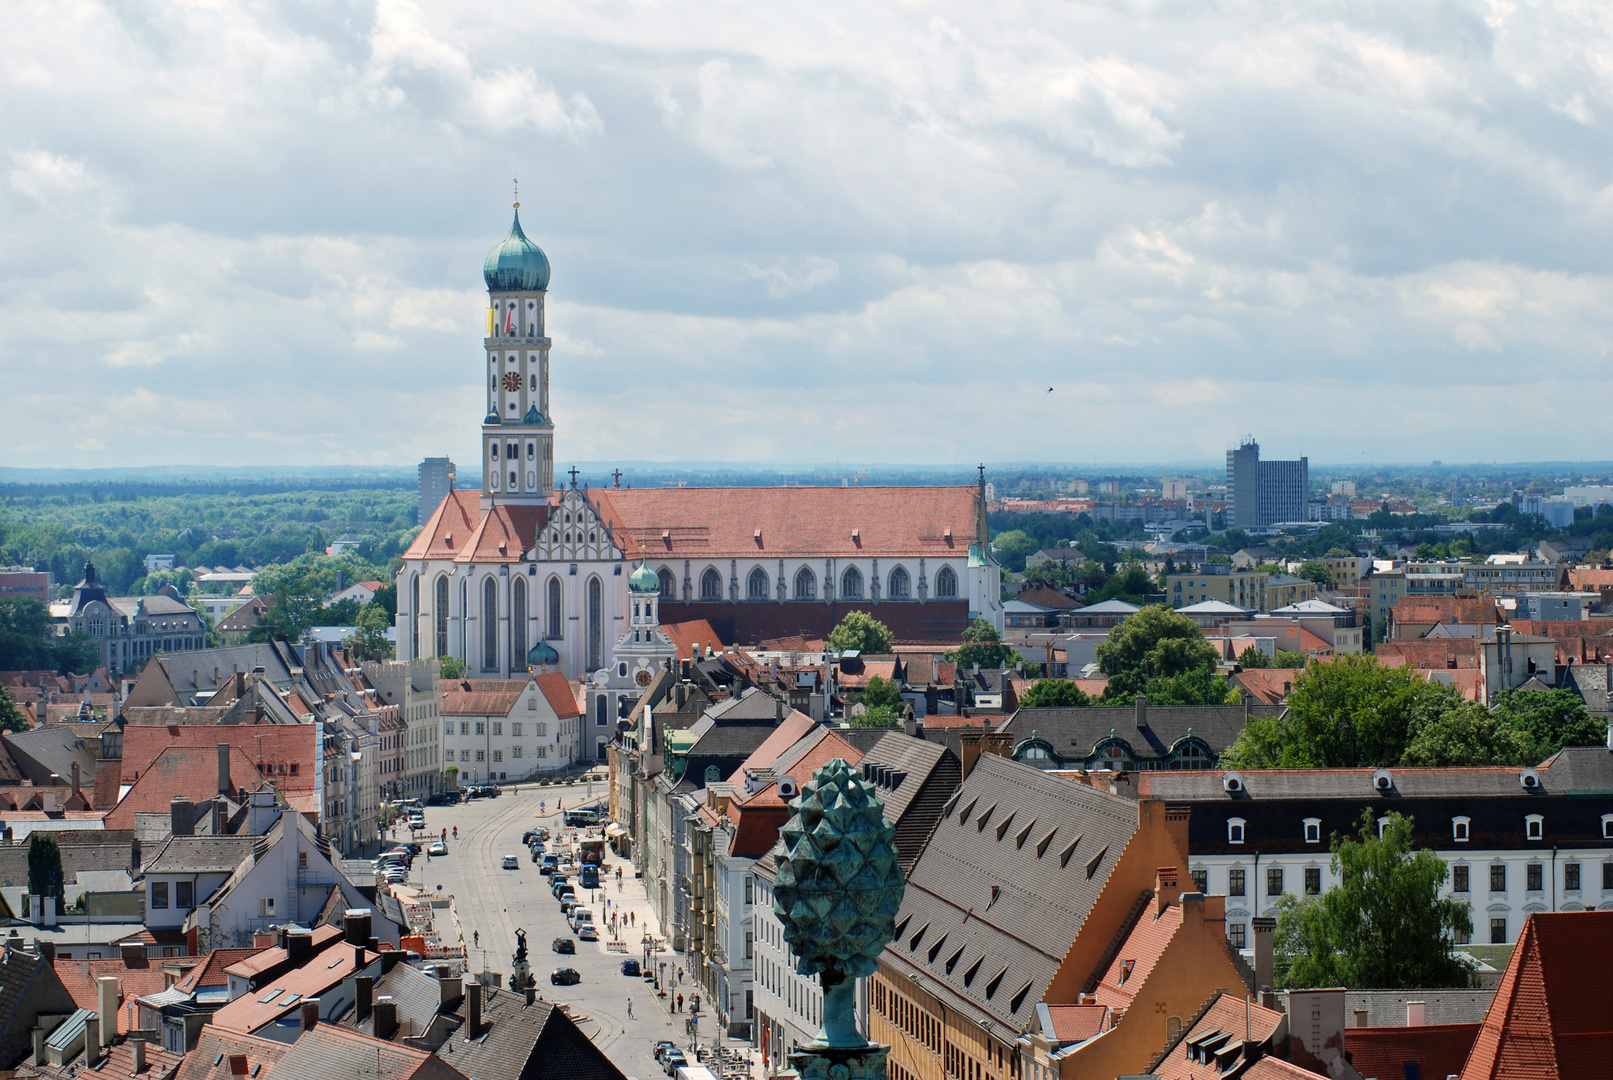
[869,753,1244,1080]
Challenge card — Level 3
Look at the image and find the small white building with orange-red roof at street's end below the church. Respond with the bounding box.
[437,672,582,783]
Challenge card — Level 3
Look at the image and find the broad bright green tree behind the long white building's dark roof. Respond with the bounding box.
[1219,654,1453,769]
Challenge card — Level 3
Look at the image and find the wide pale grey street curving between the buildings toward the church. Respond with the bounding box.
[385,782,732,1080]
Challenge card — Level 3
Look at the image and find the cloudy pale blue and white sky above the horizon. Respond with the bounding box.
[0,0,1613,467]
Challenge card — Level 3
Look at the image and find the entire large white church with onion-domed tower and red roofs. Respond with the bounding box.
[397,213,1003,753]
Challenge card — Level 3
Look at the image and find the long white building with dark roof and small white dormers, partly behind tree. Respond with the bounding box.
[1123,746,1613,949]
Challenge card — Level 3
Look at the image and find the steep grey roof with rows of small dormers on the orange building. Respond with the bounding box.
[884,754,1139,1032]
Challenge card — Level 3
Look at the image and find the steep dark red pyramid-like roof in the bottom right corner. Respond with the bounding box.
[1461,911,1613,1080]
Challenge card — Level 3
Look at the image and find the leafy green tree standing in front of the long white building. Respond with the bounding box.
[1277,809,1474,990]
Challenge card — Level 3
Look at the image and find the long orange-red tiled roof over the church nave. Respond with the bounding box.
[594,487,976,572]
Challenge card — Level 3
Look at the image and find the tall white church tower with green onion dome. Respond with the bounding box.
[482,201,555,508]
